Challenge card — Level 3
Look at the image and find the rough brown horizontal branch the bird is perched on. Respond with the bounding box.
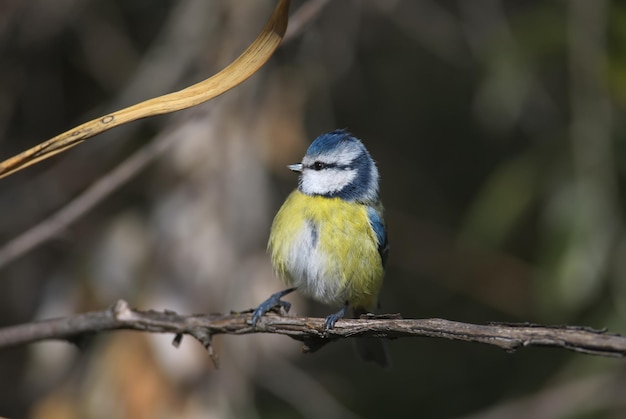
[0,300,626,357]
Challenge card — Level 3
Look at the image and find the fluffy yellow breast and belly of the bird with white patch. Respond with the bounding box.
[268,190,384,309]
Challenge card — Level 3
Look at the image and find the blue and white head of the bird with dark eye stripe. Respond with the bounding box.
[288,130,378,202]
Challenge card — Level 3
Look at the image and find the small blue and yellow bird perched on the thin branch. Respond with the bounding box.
[252,129,389,366]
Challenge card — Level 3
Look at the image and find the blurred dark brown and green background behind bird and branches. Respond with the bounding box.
[0,0,626,419]
